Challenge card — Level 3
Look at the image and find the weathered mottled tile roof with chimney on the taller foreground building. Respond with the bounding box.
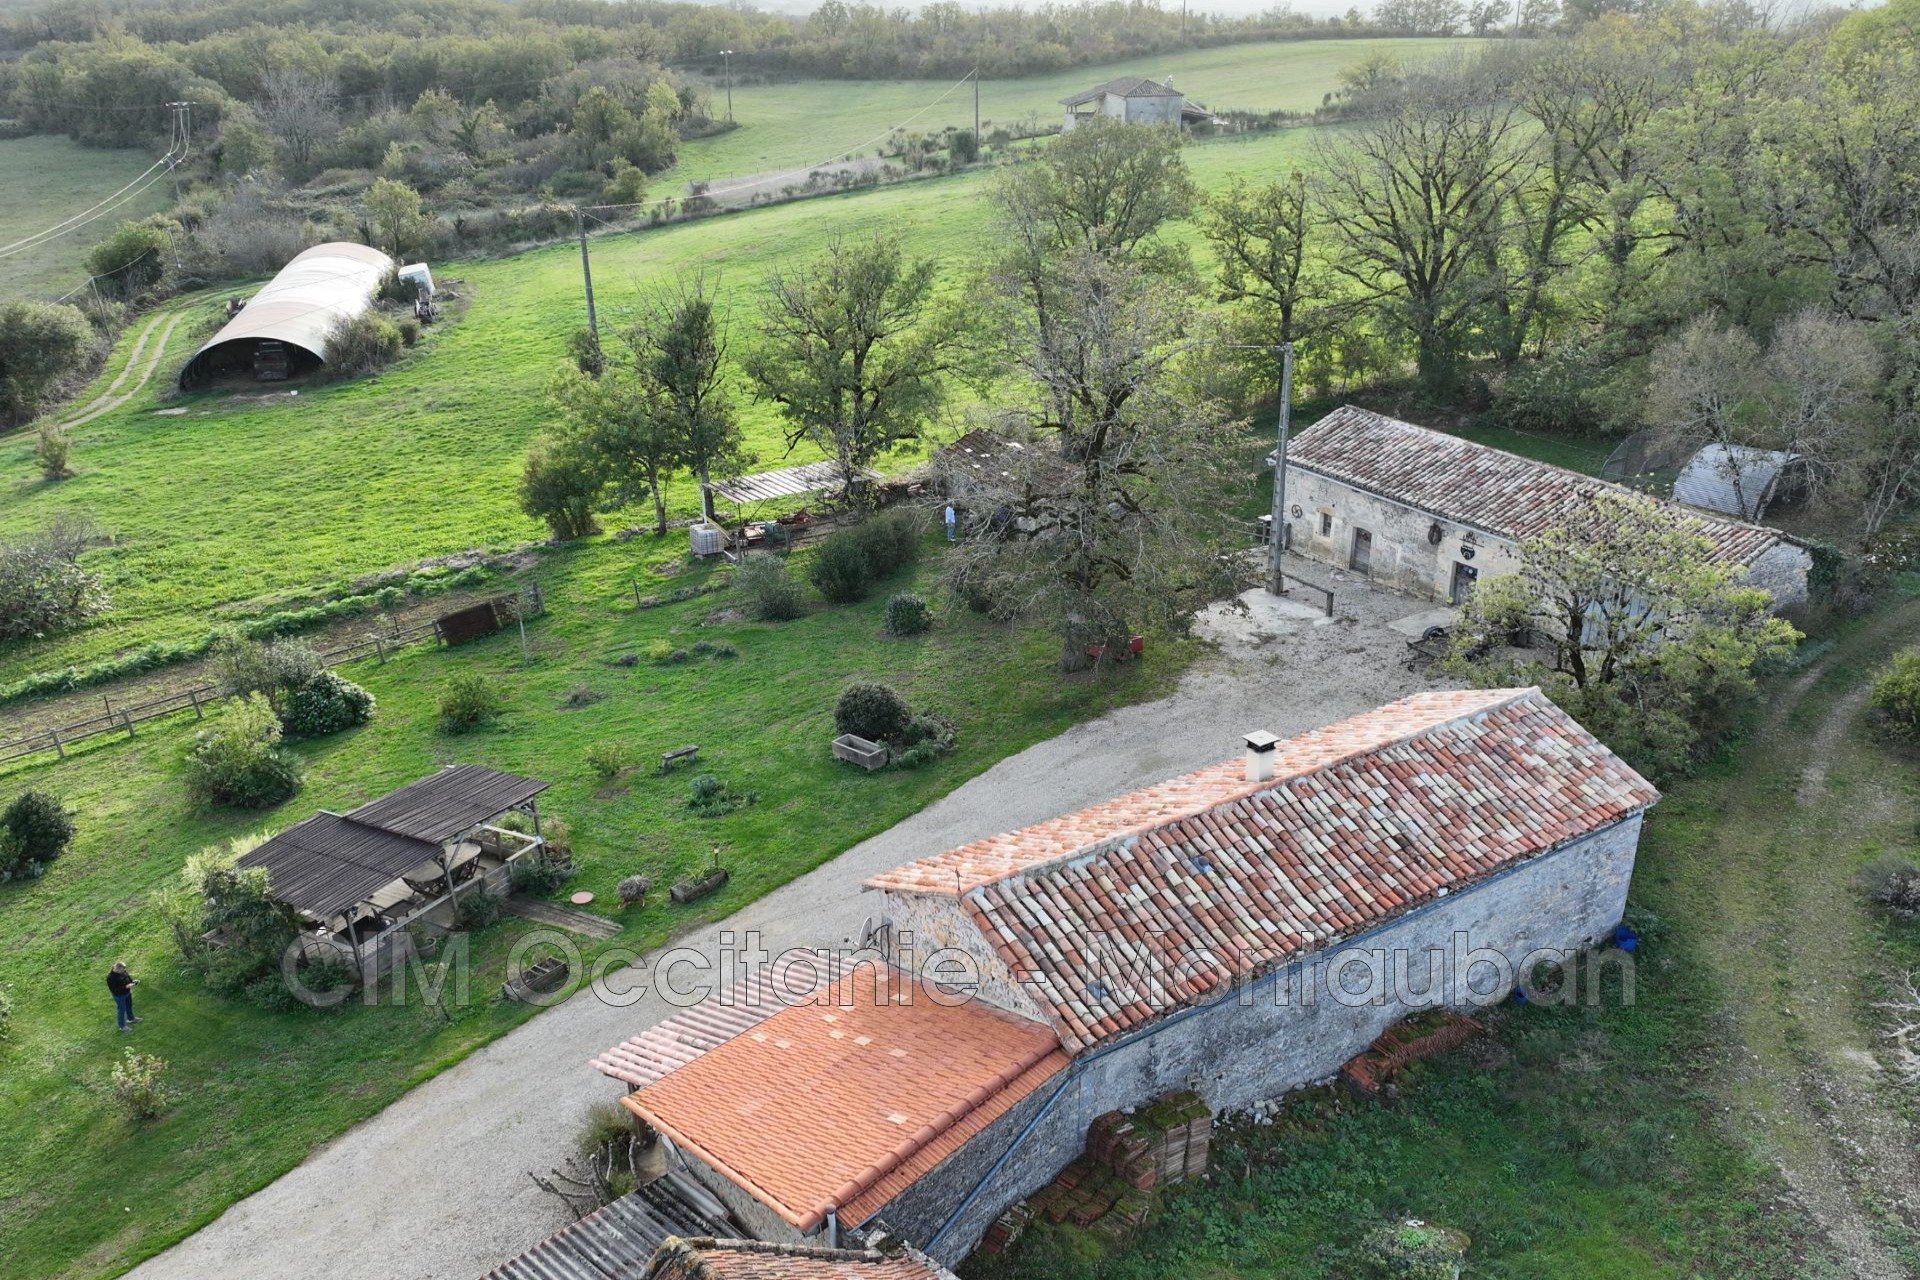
[868,689,1659,1052]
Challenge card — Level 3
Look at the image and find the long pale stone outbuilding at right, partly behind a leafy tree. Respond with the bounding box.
[1286,405,1812,608]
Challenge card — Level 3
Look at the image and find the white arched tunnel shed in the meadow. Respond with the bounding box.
[180,242,394,391]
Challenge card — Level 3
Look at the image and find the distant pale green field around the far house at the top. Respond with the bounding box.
[675,40,1471,184]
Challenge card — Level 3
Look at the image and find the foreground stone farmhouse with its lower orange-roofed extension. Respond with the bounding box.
[593,689,1659,1265]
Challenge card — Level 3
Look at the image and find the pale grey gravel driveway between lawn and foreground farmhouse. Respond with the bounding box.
[132,589,1428,1280]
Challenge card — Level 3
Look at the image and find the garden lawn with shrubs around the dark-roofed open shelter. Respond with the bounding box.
[0,539,1188,1280]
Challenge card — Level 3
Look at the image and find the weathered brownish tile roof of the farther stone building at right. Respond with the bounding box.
[1286,405,1782,564]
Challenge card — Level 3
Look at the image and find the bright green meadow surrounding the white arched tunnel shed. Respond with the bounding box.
[0,130,1313,683]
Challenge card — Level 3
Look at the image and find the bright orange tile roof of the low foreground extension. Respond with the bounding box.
[622,965,1068,1230]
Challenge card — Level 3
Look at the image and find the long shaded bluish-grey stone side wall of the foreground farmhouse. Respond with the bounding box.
[879,816,1640,1265]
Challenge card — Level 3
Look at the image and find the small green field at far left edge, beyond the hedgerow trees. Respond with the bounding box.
[0,138,173,297]
